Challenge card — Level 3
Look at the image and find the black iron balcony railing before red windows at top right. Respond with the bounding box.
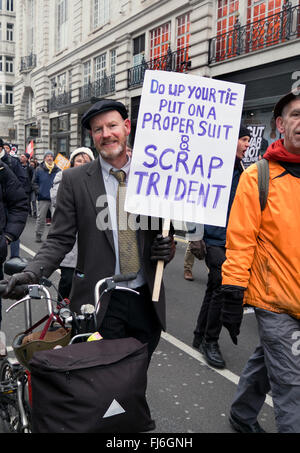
[209,2,300,64]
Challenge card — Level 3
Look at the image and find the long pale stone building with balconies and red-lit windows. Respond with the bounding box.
[14,0,300,157]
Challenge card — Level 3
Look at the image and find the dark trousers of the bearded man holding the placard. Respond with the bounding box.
[99,285,161,363]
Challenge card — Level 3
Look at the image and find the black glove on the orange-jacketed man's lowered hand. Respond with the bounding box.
[218,285,246,344]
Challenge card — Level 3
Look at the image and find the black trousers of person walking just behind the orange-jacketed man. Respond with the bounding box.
[194,246,226,342]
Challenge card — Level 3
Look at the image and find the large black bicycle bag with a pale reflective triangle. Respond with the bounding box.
[30,338,155,433]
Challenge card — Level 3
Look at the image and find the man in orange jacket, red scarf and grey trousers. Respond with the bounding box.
[219,93,300,433]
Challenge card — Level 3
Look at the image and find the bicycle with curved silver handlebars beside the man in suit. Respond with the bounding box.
[0,266,138,433]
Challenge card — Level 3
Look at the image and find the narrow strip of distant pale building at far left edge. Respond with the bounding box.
[0,0,16,143]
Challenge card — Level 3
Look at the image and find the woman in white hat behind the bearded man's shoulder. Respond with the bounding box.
[50,147,94,300]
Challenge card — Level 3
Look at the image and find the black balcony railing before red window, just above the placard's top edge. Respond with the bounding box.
[128,47,191,88]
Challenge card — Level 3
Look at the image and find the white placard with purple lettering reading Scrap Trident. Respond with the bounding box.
[125,71,245,226]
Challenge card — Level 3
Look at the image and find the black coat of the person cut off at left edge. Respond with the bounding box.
[0,160,28,264]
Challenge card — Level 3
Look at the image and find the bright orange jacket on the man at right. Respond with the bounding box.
[222,161,300,319]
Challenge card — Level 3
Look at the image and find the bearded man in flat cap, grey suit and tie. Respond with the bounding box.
[2,100,175,360]
